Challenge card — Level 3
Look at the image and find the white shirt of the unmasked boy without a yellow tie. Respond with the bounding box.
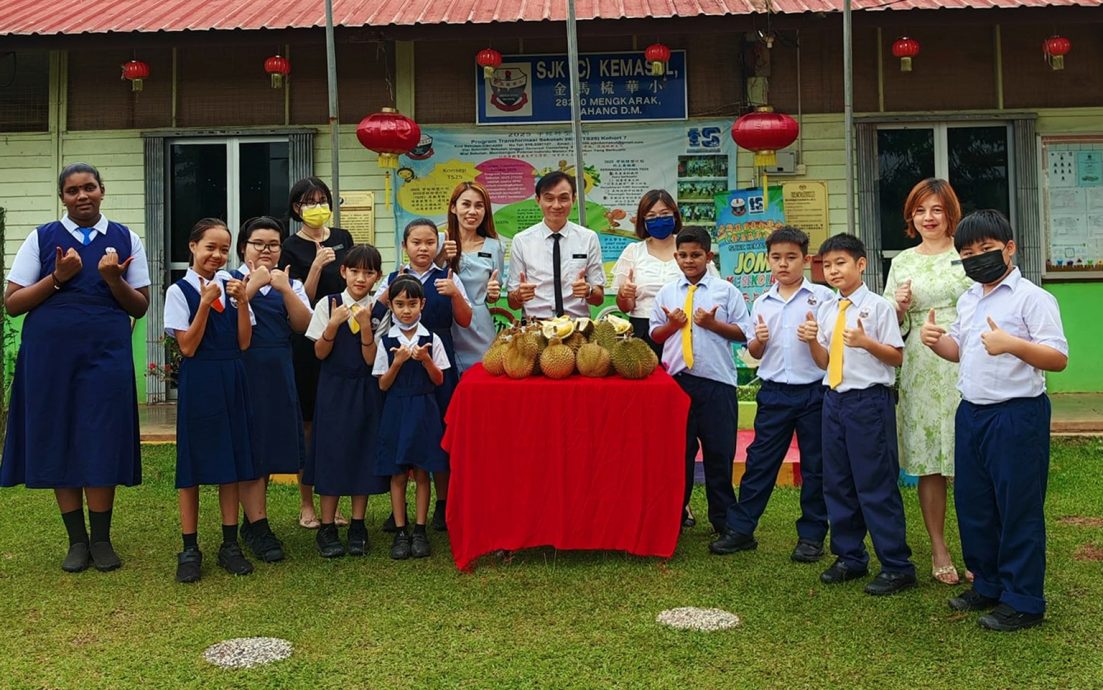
[747,278,835,385]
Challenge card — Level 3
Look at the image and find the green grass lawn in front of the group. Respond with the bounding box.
[0,439,1103,690]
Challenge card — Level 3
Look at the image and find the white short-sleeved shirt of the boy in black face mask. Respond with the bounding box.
[949,268,1069,405]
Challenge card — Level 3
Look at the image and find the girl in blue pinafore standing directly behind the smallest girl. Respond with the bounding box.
[376,218,471,530]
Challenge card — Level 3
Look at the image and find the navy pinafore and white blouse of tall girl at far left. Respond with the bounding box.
[0,216,150,488]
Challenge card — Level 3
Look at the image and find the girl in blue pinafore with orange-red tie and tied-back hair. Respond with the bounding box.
[164,218,260,582]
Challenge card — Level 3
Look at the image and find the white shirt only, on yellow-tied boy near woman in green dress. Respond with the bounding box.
[816,283,903,392]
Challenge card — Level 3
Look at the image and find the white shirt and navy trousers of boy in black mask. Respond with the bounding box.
[949,268,1069,614]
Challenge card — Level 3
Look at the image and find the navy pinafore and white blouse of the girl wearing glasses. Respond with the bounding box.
[232,265,310,475]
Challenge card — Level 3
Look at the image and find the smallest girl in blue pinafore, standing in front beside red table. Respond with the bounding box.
[372,276,452,560]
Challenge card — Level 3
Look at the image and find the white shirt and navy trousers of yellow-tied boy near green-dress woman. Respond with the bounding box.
[816,284,915,576]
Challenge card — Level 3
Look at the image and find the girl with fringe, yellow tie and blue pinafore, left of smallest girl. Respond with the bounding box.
[303,245,389,558]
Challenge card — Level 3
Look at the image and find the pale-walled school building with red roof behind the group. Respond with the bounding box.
[0,0,1103,401]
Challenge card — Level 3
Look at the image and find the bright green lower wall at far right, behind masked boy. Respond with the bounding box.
[1045,281,1103,393]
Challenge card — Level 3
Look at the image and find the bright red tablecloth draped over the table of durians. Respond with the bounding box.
[441,365,689,570]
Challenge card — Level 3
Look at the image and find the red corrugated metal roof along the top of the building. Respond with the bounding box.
[0,0,1100,35]
